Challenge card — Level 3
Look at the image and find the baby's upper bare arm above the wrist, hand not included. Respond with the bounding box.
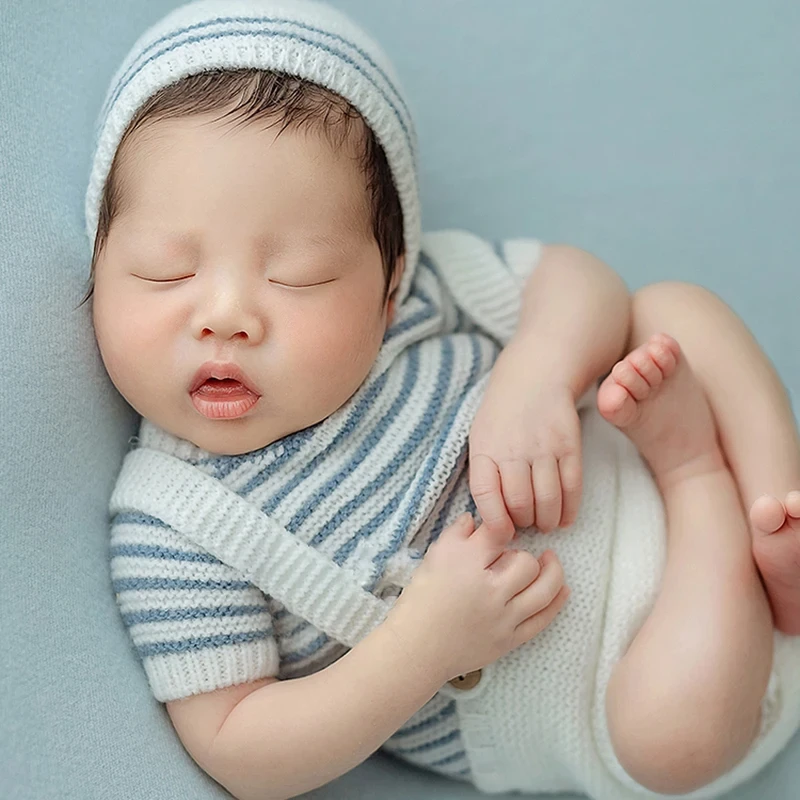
[502,245,631,399]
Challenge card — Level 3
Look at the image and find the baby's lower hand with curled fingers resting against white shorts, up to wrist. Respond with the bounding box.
[386,514,569,680]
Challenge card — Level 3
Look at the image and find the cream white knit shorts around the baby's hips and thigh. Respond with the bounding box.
[441,409,800,800]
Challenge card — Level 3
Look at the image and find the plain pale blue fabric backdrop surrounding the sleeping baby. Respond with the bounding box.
[0,0,800,800]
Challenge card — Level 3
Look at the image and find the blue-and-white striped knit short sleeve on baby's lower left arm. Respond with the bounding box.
[110,512,279,702]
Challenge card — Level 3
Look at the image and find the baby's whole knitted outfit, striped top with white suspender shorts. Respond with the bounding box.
[111,232,800,800]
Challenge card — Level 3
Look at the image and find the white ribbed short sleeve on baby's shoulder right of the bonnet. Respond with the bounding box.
[422,230,542,346]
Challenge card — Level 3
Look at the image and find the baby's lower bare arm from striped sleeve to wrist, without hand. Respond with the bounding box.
[167,623,446,800]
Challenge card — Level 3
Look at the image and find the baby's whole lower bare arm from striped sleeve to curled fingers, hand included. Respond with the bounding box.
[167,514,569,800]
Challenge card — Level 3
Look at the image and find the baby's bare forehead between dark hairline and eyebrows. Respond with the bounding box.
[106,113,372,238]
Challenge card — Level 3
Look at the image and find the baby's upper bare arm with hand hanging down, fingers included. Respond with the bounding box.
[469,245,631,534]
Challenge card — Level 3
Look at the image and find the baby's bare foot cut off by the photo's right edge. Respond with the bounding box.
[750,492,800,636]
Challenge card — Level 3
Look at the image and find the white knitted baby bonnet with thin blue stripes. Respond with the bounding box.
[86,0,421,302]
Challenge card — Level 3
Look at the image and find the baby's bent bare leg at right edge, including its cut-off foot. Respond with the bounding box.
[620,282,800,635]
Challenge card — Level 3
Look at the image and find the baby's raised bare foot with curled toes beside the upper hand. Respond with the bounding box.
[597,333,725,488]
